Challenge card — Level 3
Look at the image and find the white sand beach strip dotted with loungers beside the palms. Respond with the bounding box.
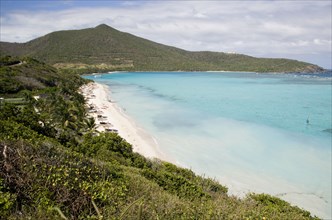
[80,83,165,159]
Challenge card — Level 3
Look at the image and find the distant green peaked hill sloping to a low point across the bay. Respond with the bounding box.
[0,24,323,72]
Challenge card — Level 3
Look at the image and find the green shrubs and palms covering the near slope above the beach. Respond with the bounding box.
[0,57,316,219]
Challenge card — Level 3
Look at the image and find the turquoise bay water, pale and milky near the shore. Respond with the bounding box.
[86,72,332,218]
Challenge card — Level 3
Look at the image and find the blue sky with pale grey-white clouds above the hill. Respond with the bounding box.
[0,0,332,69]
